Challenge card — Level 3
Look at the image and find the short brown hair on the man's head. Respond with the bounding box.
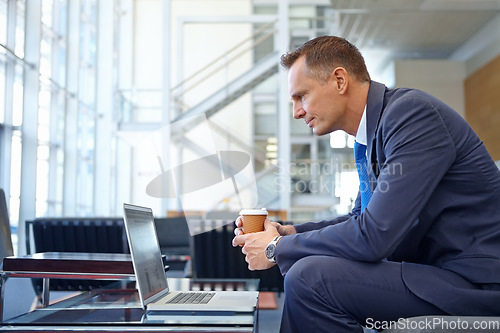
[281,36,370,83]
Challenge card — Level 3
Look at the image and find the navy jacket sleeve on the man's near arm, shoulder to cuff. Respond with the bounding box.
[276,95,456,274]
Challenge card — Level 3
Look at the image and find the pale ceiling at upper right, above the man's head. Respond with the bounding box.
[330,0,500,78]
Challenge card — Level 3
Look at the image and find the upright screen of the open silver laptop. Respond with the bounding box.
[123,204,168,307]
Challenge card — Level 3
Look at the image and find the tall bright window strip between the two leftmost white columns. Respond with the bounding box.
[36,0,68,216]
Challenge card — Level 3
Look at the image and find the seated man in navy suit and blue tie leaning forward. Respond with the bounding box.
[233,36,500,333]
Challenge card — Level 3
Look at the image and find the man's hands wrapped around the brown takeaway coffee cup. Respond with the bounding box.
[233,217,280,271]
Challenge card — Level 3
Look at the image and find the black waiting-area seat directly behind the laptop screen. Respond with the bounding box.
[26,217,190,291]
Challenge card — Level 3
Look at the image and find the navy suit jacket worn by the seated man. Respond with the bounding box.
[276,81,500,315]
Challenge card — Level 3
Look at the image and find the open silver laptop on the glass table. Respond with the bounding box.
[123,203,259,313]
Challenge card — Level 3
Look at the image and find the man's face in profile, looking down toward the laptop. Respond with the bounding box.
[288,57,345,135]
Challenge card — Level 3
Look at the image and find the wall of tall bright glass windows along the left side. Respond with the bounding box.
[0,0,121,252]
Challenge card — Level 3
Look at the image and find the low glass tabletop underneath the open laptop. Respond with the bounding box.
[2,278,259,326]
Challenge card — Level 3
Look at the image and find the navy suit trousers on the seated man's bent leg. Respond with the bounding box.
[281,256,452,333]
